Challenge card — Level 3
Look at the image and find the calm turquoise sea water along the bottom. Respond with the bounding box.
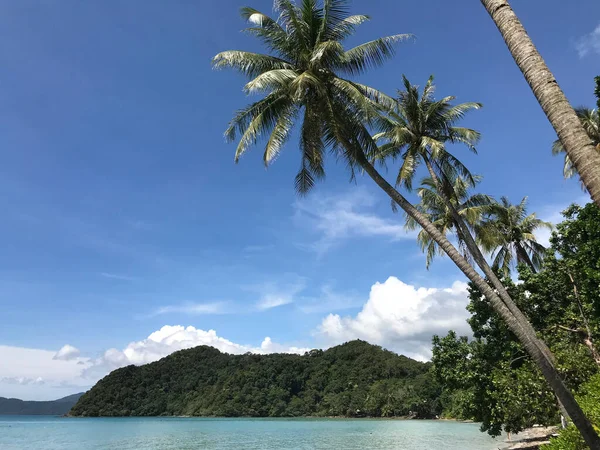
[0,416,503,450]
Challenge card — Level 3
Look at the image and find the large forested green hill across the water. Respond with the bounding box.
[70,341,439,417]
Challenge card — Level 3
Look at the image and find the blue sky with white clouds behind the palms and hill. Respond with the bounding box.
[0,0,600,400]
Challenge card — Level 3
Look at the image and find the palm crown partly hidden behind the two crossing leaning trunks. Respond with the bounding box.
[406,176,493,268]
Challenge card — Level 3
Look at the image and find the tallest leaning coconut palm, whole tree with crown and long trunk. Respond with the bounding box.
[213,0,593,442]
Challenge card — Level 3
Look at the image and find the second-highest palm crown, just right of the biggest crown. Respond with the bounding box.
[374,76,482,190]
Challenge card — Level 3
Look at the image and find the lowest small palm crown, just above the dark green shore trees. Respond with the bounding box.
[476,197,552,276]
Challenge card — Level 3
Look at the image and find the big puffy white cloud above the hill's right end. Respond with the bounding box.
[316,277,470,360]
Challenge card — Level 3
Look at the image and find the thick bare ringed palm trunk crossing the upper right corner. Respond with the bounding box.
[481,0,600,206]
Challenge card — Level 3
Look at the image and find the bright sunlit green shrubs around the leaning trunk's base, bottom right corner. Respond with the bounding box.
[541,374,600,450]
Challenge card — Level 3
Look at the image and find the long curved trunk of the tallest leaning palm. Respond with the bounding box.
[356,152,600,450]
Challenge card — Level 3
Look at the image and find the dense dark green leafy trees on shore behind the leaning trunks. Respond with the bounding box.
[433,203,600,435]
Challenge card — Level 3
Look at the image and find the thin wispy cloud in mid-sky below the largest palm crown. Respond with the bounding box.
[294,188,415,254]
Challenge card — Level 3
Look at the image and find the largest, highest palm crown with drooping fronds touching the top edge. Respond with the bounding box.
[213,0,409,194]
